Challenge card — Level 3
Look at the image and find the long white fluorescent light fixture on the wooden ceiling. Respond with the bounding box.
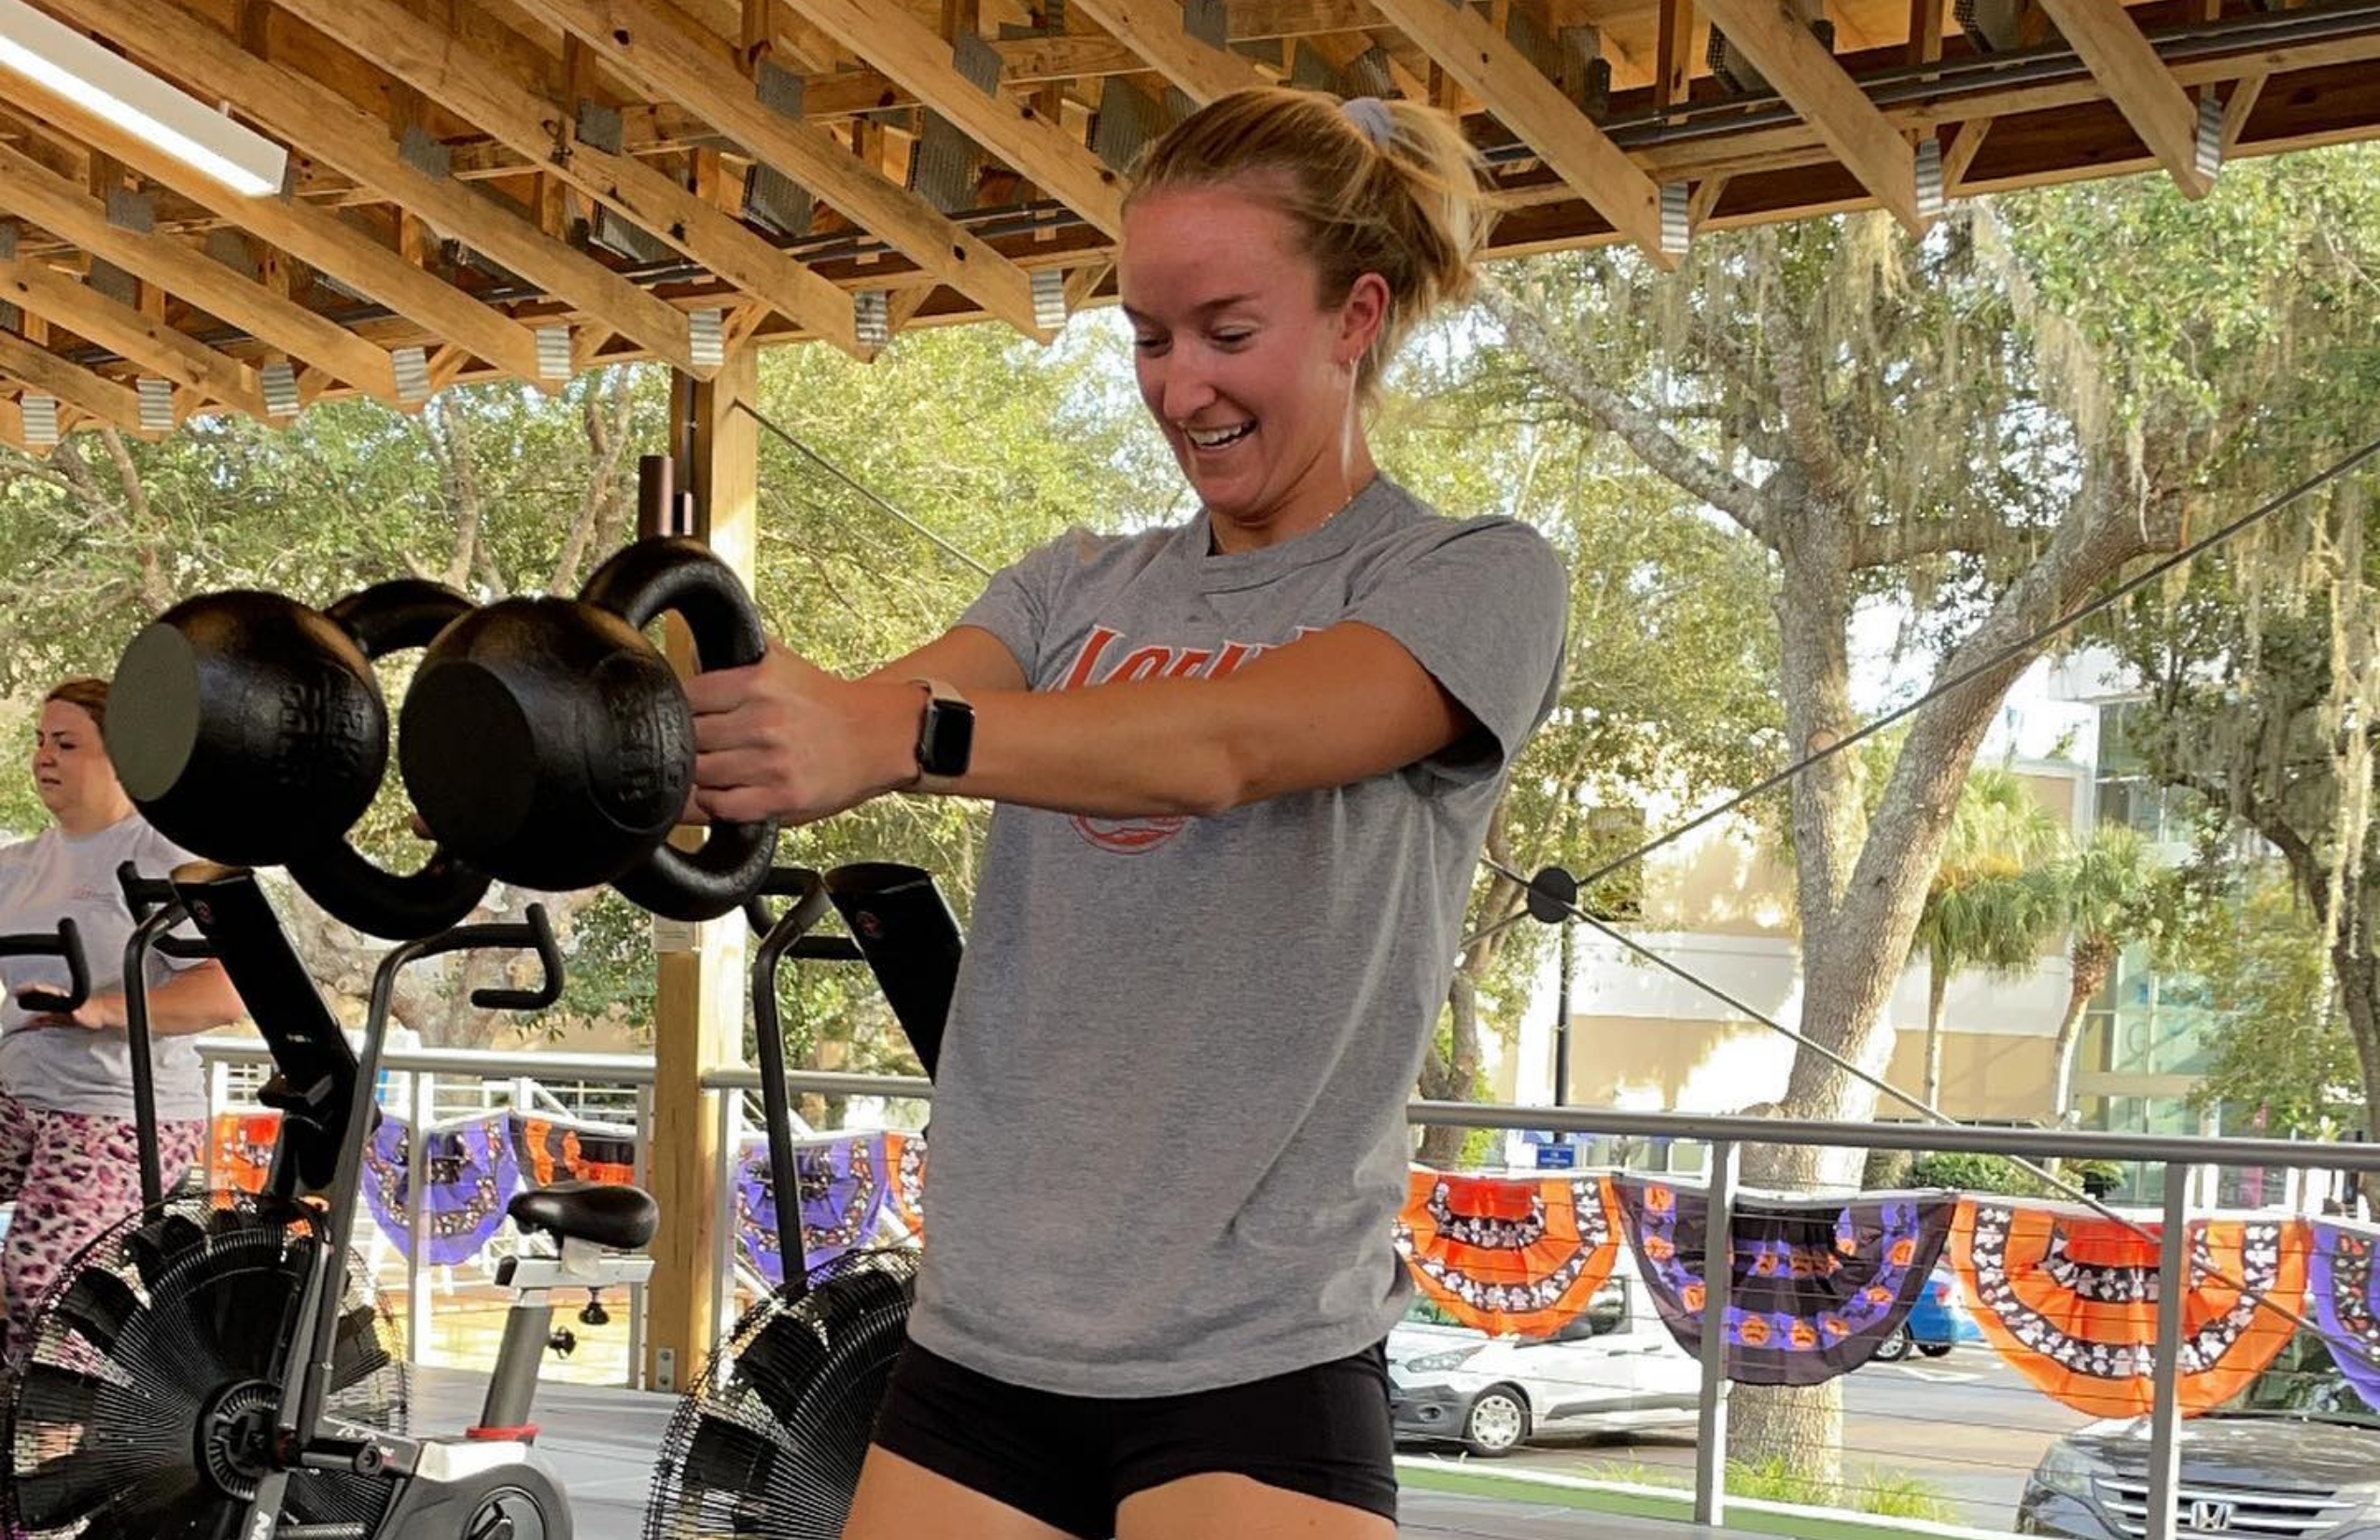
[0,0,288,198]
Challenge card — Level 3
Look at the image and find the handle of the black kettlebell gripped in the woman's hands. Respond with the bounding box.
[579,536,776,918]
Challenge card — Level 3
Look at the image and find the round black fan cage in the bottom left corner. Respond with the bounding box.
[0,1193,407,1540]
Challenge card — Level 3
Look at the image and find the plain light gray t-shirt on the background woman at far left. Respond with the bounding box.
[0,814,207,1121]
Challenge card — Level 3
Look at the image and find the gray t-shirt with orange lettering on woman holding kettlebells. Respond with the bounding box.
[909,476,1568,1397]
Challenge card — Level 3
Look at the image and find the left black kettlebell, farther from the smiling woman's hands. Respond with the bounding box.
[107,579,488,940]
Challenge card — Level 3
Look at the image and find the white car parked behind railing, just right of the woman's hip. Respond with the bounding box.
[1388,1259,1701,1457]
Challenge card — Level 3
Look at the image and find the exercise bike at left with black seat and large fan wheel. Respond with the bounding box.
[0,864,659,1540]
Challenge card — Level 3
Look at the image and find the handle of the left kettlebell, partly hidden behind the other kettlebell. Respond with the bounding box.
[288,579,488,940]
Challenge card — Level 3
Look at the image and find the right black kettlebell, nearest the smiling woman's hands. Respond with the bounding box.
[398,538,776,918]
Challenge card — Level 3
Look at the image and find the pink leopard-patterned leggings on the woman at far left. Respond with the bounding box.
[0,1093,207,1364]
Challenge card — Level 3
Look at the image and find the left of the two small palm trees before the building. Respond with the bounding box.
[1911,769,2065,1107]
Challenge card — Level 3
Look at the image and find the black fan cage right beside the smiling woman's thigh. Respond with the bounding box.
[645,1247,918,1540]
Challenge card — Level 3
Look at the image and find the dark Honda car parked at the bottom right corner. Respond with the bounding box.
[2016,1333,2380,1540]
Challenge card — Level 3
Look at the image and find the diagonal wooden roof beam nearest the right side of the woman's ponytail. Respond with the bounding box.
[1380,0,1678,267]
